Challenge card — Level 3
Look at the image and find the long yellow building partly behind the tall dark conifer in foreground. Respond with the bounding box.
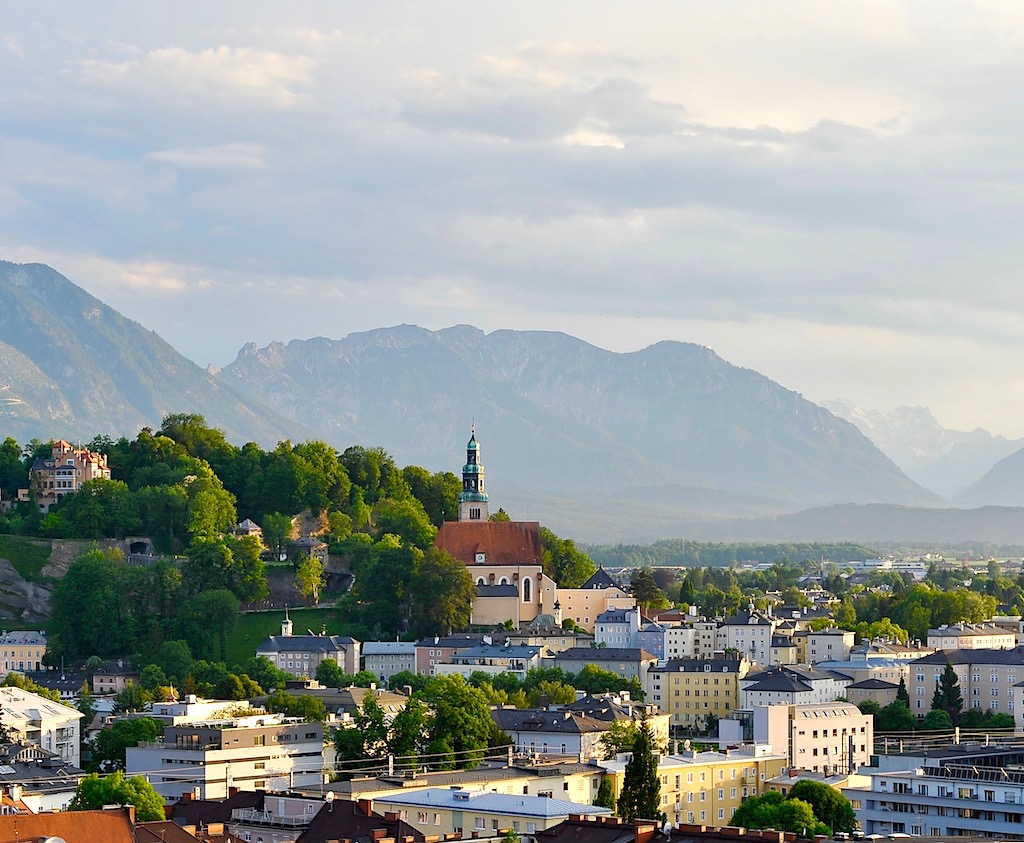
[601,746,788,826]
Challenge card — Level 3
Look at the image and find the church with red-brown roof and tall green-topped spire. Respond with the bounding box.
[434,425,561,628]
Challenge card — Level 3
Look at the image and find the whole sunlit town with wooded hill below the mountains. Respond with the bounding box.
[0,426,1024,843]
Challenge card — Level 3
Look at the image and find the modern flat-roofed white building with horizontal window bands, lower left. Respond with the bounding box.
[125,714,325,802]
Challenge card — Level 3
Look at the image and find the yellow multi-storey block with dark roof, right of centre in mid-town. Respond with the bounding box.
[644,659,751,728]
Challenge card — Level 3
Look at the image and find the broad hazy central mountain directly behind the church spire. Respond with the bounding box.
[220,326,938,510]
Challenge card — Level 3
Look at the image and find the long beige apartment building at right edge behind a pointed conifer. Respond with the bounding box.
[906,647,1024,718]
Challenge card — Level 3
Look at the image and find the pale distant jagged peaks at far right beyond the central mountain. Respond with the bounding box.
[822,401,1024,497]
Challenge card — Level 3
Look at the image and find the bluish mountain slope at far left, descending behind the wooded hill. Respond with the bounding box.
[0,261,303,445]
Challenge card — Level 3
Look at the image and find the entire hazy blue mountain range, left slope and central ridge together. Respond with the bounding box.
[0,262,1024,541]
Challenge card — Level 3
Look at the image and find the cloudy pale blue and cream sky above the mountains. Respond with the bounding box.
[0,0,1024,437]
